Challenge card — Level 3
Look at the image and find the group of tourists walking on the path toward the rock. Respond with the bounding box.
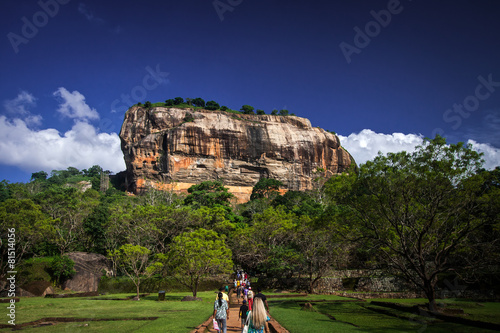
[213,271,270,333]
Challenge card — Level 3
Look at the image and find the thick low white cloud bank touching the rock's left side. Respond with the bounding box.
[0,116,125,172]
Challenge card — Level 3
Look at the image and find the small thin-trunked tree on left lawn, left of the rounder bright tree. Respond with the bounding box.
[108,244,163,300]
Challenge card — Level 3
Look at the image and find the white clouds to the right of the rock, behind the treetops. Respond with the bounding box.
[338,129,500,169]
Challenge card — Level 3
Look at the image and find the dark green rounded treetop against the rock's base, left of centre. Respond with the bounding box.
[184,180,234,209]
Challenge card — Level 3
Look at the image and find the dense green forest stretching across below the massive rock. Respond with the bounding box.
[0,136,500,308]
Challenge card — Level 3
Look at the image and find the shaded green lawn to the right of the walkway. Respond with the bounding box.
[269,295,500,333]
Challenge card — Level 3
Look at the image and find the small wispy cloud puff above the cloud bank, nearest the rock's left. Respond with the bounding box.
[54,87,99,120]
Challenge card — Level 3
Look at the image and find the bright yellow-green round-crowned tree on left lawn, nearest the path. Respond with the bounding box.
[168,229,233,297]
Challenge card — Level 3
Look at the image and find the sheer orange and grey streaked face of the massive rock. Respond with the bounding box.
[120,106,353,201]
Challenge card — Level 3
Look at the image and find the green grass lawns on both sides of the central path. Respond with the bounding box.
[0,291,500,333]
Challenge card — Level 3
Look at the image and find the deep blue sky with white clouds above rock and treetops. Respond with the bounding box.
[0,0,500,182]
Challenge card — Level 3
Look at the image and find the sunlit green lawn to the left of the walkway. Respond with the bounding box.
[0,291,215,333]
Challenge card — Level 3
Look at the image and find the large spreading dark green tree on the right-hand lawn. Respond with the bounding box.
[336,136,491,311]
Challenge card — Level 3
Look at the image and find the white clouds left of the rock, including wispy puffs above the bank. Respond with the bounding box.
[0,88,125,172]
